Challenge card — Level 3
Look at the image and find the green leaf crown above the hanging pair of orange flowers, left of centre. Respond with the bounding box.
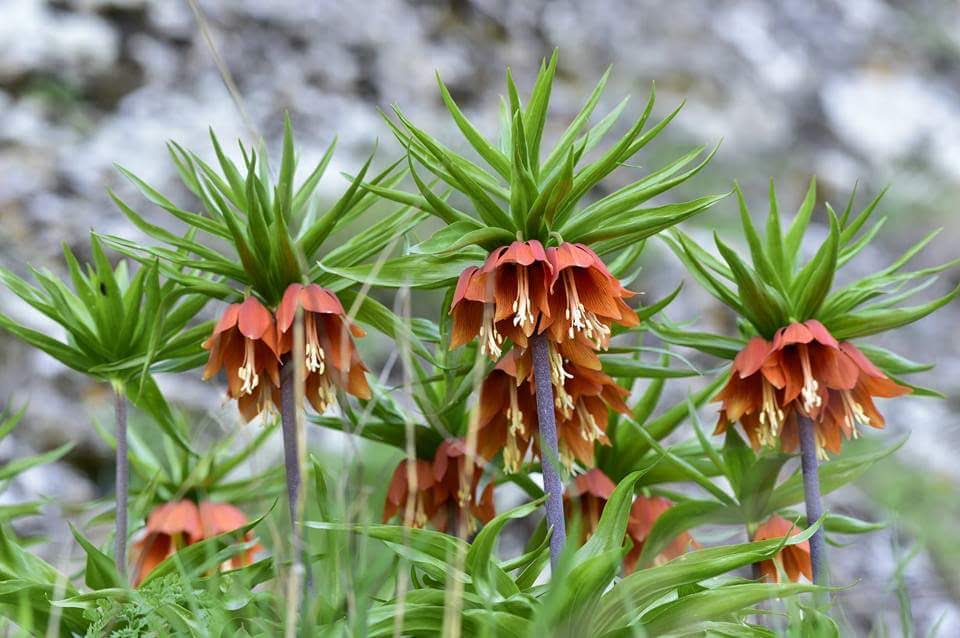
[105,118,414,307]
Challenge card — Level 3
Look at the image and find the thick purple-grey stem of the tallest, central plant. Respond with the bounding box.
[530,334,567,570]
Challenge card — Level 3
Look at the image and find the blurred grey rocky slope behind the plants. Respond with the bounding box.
[0,0,960,636]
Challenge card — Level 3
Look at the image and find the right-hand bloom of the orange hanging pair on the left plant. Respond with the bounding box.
[277,284,371,412]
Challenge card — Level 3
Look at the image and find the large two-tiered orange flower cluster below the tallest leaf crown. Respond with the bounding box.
[464,240,639,472]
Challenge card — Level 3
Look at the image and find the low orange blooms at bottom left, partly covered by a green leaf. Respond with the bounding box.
[133,500,261,585]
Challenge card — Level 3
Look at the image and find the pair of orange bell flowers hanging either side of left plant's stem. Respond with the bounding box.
[203,284,371,421]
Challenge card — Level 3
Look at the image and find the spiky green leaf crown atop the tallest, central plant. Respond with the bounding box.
[330,52,725,288]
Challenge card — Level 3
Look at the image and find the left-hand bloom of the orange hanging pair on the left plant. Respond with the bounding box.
[203,297,280,421]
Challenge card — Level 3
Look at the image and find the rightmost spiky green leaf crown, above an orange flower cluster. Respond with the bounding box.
[664,180,960,342]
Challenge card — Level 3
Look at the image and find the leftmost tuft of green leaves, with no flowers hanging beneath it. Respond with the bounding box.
[0,236,212,449]
